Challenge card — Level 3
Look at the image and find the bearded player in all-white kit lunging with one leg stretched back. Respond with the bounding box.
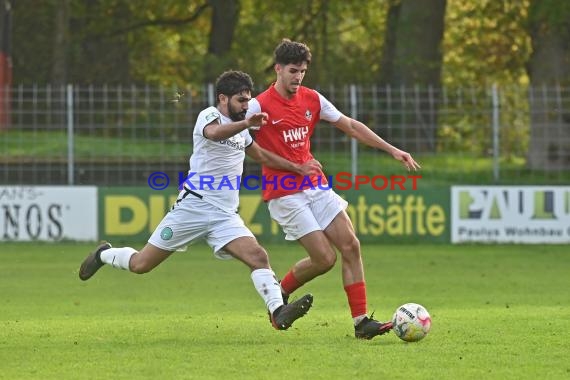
[79,71,320,330]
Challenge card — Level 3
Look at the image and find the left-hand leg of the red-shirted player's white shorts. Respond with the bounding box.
[268,192,322,240]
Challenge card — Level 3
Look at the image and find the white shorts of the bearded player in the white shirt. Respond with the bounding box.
[148,192,253,259]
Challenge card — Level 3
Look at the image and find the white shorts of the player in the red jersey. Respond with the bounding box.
[268,189,348,240]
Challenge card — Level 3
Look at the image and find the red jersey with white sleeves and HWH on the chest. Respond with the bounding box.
[249,85,342,201]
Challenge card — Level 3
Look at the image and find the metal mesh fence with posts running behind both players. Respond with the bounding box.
[0,85,570,186]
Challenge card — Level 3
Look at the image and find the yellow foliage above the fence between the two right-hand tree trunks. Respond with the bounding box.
[443,0,531,86]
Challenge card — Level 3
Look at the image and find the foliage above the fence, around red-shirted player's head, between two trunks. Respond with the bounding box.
[233,0,386,86]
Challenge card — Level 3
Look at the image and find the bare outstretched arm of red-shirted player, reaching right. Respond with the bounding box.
[333,115,421,170]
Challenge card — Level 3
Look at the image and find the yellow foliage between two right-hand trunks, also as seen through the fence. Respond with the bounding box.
[438,0,531,162]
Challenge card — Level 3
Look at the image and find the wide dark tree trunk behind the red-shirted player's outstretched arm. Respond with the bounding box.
[374,0,447,152]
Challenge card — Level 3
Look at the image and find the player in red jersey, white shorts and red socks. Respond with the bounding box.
[248,39,420,339]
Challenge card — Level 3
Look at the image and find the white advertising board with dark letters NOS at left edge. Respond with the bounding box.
[0,186,98,241]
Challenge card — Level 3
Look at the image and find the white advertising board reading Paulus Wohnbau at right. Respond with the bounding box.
[451,186,570,243]
